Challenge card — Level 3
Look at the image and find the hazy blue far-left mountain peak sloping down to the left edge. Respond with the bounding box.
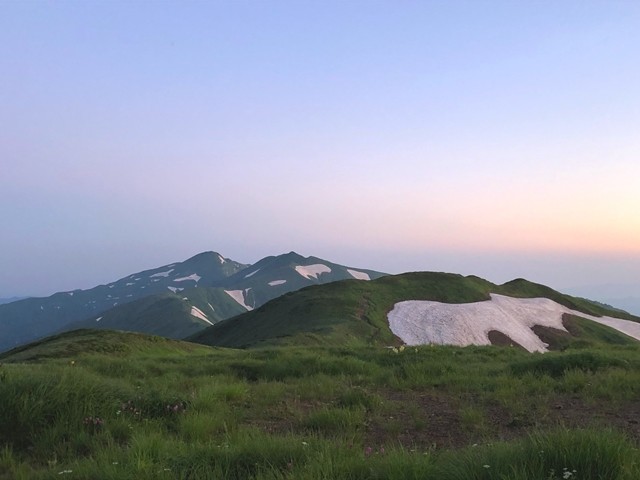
[0,252,247,351]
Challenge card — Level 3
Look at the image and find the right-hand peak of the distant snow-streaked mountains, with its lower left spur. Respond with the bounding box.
[65,252,384,338]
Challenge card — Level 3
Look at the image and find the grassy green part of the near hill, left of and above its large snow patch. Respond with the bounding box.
[189,272,640,347]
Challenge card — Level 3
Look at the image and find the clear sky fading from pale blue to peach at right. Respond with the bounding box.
[0,0,640,297]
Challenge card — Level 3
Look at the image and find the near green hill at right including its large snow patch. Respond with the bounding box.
[188,272,640,351]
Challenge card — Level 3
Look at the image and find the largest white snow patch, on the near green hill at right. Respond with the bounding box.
[387,293,640,352]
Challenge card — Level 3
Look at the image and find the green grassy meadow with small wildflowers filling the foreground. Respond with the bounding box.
[0,326,640,480]
